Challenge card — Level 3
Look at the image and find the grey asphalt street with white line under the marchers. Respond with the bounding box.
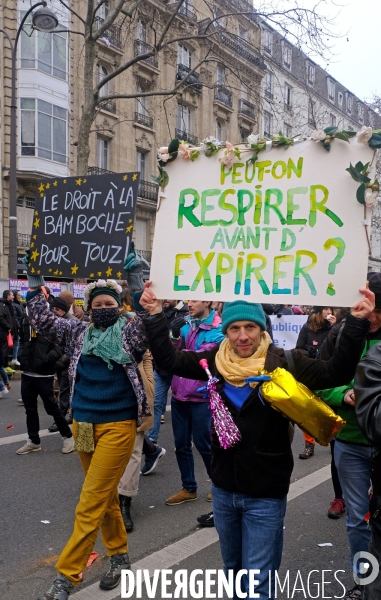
[0,382,353,600]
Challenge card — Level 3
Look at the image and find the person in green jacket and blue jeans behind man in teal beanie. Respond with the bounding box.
[317,273,381,599]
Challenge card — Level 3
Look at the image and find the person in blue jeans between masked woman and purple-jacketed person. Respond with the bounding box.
[142,300,188,448]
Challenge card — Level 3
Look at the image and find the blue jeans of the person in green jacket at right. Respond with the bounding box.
[335,439,374,577]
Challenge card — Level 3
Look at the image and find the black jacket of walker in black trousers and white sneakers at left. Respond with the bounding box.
[17,316,63,375]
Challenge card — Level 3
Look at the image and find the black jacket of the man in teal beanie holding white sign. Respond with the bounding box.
[144,313,369,498]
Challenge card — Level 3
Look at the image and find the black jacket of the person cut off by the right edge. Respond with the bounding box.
[354,342,381,527]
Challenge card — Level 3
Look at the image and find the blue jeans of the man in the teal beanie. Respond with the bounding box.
[212,485,287,600]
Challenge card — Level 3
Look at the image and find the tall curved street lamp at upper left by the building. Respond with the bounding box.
[0,0,58,278]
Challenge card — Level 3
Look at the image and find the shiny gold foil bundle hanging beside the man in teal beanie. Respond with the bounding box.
[261,367,345,446]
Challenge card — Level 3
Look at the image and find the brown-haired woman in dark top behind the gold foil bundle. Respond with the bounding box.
[296,306,336,459]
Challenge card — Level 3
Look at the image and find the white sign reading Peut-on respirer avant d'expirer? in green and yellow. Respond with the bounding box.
[151,139,373,306]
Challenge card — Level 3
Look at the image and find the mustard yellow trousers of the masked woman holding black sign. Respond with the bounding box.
[56,421,136,585]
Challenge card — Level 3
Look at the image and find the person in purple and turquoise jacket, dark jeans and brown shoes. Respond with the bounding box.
[165,300,224,506]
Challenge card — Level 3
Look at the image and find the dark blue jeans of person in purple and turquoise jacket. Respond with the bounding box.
[171,398,212,493]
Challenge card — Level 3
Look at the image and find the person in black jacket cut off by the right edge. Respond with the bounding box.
[354,342,381,600]
